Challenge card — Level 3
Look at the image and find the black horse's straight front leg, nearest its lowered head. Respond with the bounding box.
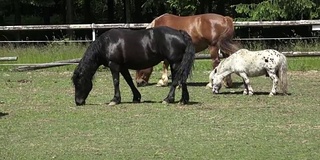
[109,62,121,105]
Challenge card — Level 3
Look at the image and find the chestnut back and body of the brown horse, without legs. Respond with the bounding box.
[150,13,234,52]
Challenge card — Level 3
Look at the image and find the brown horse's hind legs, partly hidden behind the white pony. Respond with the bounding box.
[207,46,232,88]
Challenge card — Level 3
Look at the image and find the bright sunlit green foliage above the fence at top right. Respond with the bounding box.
[232,0,320,20]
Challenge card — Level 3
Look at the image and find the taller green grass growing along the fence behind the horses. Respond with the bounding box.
[0,42,320,71]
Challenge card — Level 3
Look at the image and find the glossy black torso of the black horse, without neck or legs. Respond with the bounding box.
[101,27,185,69]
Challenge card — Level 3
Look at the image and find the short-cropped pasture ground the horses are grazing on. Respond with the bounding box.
[0,64,320,160]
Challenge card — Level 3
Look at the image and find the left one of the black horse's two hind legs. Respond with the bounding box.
[162,64,179,103]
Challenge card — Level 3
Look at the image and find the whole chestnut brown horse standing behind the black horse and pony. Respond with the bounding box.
[136,13,238,87]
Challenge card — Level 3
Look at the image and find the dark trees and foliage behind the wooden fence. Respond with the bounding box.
[0,0,320,39]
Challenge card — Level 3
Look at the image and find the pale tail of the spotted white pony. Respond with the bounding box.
[278,55,288,95]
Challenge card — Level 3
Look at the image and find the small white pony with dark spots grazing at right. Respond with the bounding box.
[209,49,288,96]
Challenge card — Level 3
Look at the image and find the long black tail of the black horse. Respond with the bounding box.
[176,30,195,83]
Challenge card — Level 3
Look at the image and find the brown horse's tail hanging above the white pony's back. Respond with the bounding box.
[217,16,239,57]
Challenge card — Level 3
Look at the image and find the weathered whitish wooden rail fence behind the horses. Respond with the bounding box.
[0,20,320,65]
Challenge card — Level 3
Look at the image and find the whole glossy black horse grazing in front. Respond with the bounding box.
[72,27,195,105]
